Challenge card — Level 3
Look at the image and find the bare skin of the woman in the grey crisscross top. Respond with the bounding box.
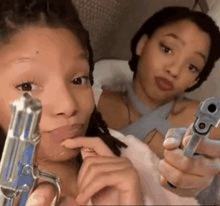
[99,20,220,196]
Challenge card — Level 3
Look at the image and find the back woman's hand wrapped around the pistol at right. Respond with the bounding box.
[159,127,220,197]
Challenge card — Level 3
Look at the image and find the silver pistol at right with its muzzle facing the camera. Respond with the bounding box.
[183,97,220,158]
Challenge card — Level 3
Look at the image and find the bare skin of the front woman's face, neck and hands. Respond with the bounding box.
[0,26,142,206]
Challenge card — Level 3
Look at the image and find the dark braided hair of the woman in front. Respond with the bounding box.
[0,0,126,159]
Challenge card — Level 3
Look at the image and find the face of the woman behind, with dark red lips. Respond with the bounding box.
[135,20,210,103]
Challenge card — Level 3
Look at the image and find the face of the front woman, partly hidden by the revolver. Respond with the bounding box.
[0,26,94,161]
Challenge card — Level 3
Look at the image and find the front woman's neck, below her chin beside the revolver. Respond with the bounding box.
[38,159,79,198]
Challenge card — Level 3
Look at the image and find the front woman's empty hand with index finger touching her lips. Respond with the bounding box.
[63,137,143,205]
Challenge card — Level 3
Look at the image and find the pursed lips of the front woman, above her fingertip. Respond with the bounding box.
[49,124,84,142]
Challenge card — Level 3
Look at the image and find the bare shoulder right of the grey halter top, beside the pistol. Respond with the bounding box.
[170,98,199,127]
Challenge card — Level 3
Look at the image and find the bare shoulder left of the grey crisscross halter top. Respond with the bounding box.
[98,90,128,129]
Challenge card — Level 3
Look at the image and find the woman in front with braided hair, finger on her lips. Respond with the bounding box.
[0,0,143,206]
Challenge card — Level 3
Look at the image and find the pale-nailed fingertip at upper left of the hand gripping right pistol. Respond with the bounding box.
[163,127,186,150]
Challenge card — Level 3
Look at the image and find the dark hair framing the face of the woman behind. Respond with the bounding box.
[129,7,220,92]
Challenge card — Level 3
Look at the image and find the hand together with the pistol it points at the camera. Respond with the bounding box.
[159,97,220,201]
